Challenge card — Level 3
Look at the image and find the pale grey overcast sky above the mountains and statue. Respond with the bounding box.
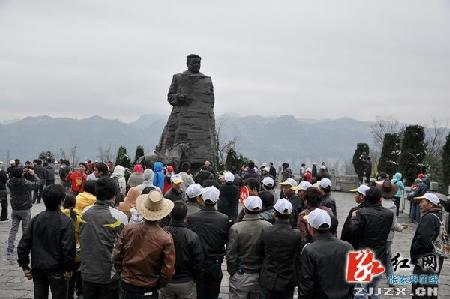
[0,0,450,123]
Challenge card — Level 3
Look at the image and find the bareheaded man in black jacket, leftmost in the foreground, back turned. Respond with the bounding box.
[17,185,76,298]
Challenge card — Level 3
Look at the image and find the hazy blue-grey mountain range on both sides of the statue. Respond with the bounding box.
[0,114,371,168]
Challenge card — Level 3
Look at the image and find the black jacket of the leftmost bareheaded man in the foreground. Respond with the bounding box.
[17,210,75,271]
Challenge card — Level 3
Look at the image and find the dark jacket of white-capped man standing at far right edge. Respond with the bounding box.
[410,208,441,264]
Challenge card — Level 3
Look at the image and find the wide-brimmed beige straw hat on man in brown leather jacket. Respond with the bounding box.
[136,190,174,221]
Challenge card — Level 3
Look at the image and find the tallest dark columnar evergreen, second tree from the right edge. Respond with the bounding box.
[399,125,425,185]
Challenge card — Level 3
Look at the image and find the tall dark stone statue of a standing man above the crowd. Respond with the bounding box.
[155,54,217,170]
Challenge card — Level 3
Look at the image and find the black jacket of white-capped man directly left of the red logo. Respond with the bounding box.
[298,232,354,299]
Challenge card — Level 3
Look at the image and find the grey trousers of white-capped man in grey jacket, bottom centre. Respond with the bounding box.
[230,272,261,299]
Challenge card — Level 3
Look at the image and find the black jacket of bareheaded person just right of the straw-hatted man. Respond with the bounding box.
[164,221,204,283]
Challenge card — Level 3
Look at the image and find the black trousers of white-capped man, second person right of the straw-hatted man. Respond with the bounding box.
[197,257,223,299]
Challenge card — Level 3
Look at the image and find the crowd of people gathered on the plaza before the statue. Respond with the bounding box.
[0,160,442,299]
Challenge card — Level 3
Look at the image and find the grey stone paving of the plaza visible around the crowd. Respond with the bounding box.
[0,193,450,299]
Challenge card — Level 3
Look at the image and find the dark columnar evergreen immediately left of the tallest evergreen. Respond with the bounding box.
[378,133,400,178]
